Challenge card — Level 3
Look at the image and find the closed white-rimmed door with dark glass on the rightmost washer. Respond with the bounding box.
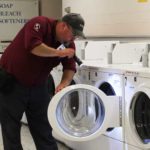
[128,87,150,149]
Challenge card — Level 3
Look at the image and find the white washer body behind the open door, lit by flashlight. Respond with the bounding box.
[80,65,125,142]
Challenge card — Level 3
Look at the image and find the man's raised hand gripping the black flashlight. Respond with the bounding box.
[58,48,75,58]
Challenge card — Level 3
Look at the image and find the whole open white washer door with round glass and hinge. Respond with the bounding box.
[48,84,121,141]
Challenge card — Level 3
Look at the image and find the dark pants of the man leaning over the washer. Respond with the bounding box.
[0,79,57,150]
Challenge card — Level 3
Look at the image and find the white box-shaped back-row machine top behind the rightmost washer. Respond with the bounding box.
[112,42,148,68]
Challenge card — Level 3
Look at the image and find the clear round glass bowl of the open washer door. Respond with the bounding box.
[56,89,105,137]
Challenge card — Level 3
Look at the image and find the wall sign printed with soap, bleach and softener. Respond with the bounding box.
[0,0,39,41]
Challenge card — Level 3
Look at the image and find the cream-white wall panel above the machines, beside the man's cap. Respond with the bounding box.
[63,0,150,37]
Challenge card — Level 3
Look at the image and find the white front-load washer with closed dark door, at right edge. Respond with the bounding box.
[125,68,150,150]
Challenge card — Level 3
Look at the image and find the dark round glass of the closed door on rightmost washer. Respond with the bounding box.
[130,92,150,144]
